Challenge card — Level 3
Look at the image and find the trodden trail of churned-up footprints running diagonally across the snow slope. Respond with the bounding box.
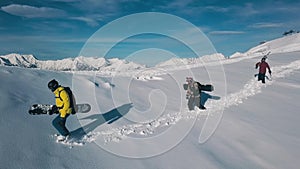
[83,60,300,143]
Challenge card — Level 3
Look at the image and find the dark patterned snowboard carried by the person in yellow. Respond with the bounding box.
[28,103,91,115]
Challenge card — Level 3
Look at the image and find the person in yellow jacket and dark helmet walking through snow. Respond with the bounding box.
[48,79,72,141]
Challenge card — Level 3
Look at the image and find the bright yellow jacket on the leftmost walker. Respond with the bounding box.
[53,86,72,118]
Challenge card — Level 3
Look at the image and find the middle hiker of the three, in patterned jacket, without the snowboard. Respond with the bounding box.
[186,77,206,110]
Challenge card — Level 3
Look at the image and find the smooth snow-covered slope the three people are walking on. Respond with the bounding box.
[0,34,300,169]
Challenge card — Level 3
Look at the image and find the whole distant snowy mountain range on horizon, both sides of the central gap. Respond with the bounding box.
[0,53,224,72]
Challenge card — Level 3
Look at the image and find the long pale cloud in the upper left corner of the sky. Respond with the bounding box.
[1,4,66,18]
